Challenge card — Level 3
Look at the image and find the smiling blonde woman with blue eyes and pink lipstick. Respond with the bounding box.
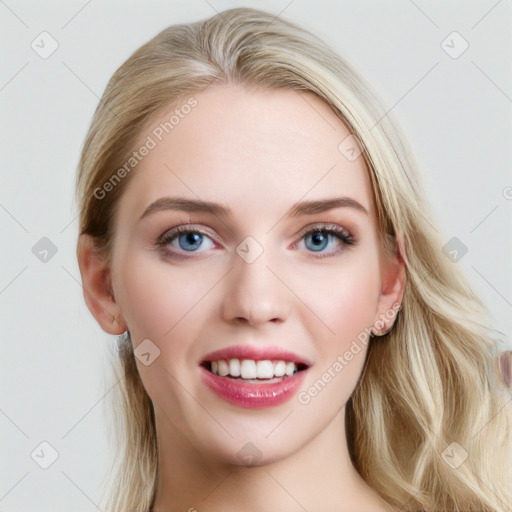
[77,8,511,512]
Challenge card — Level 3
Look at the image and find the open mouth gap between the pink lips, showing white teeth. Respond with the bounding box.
[201,358,308,384]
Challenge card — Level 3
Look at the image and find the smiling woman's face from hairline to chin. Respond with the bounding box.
[105,85,400,464]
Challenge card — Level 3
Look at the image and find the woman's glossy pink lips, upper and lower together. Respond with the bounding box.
[200,345,311,409]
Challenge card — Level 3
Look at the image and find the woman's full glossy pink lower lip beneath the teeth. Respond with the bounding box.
[201,367,307,409]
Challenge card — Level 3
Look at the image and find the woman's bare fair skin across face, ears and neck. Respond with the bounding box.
[78,85,405,512]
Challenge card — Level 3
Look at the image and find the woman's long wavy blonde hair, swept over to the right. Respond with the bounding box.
[77,8,512,512]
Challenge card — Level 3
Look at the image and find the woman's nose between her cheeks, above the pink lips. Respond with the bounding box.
[221,252,291,326]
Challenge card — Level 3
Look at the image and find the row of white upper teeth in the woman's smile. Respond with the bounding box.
[211,359,297,379]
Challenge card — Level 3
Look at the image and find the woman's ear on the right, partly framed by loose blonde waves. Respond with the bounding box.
[372,234,406,336]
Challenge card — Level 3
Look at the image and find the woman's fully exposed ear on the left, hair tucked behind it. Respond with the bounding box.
[76,235,126,334]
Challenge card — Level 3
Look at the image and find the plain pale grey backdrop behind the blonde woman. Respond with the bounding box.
[0,0,512,512]
